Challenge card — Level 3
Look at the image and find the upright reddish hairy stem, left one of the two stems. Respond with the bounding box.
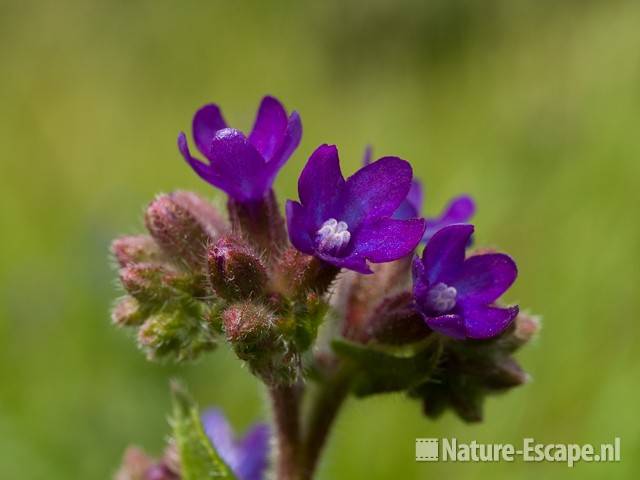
[269,385,302,480]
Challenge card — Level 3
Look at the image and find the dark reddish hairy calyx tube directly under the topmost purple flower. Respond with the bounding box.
[227,190,288,258]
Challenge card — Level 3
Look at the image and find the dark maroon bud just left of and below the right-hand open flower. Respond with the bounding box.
[367,292,431,345]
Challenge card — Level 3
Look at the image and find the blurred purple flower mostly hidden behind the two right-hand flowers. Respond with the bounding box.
[363,146,476,243]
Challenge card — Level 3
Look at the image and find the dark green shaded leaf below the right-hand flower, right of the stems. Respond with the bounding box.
[332,340,442,397]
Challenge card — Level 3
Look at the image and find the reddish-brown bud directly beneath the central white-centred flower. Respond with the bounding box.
[276,247,340,298]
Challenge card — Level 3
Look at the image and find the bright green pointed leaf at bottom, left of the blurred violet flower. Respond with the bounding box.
[171,381,236,480]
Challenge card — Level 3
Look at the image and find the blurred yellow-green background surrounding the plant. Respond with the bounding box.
[0,0,640,479]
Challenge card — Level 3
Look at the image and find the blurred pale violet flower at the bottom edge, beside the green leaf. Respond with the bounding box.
[202,409,270,480]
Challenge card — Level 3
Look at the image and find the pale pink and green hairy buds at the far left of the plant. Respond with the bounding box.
[111,192,227,360]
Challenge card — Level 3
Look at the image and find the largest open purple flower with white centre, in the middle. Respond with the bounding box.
[287,145,425,273]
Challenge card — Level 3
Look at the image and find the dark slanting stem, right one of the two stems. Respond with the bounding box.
[302,368,351,480]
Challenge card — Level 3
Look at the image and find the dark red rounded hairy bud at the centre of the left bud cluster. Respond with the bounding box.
[207,236,268,301]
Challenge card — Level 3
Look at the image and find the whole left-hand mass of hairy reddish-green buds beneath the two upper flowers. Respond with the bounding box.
[111,192,337,384]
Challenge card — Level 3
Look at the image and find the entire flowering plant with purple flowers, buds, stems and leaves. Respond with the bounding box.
[112,97,538,480]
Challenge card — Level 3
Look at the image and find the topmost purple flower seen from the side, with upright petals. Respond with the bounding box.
[178,97,302,203]
